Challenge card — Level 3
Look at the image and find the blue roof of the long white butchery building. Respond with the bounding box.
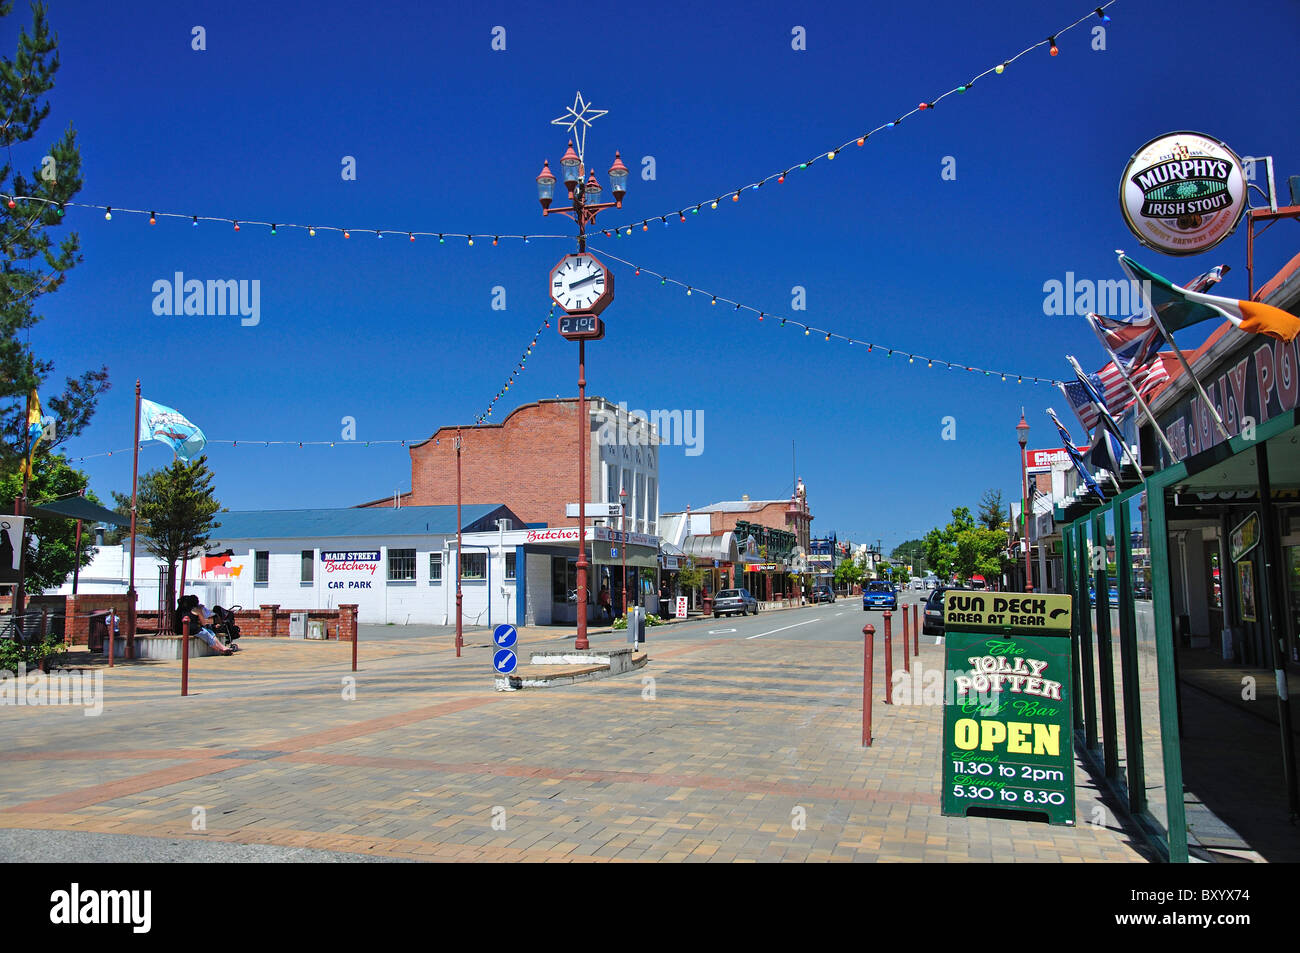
[209,503,523,546]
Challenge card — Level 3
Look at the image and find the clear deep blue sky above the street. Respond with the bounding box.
[12,0,1300,546]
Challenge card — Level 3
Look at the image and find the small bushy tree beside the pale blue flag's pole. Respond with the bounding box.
[135,456,221,621]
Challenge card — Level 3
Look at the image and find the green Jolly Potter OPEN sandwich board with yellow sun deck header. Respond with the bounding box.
[943,590,1075,826]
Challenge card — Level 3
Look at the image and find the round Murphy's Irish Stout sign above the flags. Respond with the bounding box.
[1119,133,1247,255]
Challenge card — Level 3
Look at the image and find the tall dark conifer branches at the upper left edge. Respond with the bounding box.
[0,0,108,472]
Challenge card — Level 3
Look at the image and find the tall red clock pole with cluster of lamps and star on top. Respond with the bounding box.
[537,92,628,650]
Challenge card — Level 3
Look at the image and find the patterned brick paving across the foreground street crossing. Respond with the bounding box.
[0,631,1152,862]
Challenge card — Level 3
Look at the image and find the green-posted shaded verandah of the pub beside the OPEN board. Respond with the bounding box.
[1060,410,1300,862]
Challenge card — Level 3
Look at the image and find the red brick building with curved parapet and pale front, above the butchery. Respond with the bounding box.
[361,397,659,536]
